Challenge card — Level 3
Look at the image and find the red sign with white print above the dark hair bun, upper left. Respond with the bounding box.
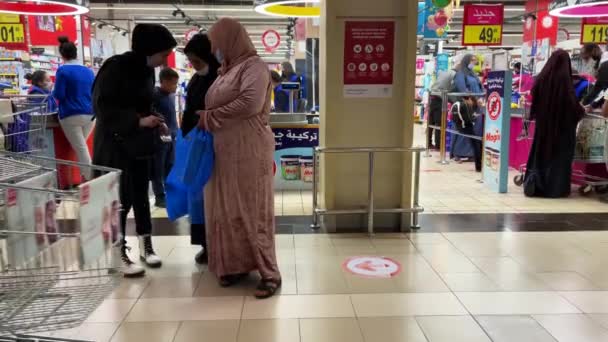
[28,15,78,46]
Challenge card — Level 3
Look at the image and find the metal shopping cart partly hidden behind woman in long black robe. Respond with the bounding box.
[513,114,608,196]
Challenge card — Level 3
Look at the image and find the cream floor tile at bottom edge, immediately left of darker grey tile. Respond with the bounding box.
[416,316,491,342]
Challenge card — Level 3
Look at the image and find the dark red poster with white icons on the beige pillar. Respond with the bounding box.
[344,21,395,98]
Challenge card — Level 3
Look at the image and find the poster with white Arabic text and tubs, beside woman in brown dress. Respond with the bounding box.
[272,126,319,190]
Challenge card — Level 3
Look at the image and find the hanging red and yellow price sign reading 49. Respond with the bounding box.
[462,4,505,46]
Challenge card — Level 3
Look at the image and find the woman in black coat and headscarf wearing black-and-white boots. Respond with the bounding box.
[93,24,177,276]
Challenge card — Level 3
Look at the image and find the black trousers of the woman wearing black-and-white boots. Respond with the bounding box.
[120,159,152,239]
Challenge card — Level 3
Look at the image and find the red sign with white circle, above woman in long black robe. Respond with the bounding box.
[524,0,559,45]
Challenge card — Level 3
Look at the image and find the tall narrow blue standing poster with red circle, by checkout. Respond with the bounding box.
[483,71,512,193]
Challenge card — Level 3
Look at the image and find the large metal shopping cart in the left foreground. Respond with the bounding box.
[0,151,120,341]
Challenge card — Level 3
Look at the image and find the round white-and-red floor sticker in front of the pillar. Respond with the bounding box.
[342,256,401,278]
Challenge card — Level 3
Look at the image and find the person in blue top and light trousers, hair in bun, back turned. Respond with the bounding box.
[53,37,95,180]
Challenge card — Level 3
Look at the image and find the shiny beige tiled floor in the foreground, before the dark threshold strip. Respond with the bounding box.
[39,231,608,342]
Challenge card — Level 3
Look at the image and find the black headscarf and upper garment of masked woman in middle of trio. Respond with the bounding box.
[181,33,220,136]
